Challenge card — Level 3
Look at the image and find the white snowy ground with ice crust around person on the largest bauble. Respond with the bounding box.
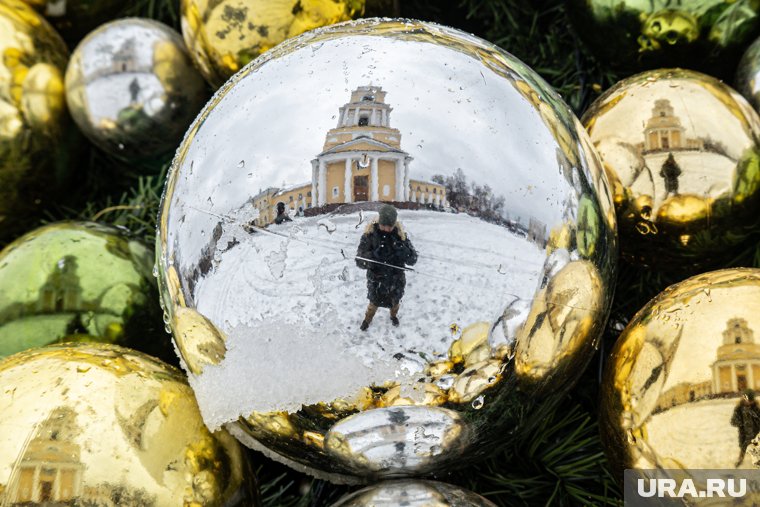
[191,210,546,426]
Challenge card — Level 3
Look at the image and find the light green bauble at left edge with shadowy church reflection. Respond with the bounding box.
[0,222,176,363]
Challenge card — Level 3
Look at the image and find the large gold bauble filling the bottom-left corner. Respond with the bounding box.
[0,343,259,507]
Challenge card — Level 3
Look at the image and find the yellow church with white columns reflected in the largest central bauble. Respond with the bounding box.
[253,86,446,225]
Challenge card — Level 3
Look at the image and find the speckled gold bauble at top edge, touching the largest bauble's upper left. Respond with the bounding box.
[181,0,366,88]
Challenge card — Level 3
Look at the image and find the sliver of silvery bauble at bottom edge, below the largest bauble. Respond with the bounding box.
[332,479,496,507]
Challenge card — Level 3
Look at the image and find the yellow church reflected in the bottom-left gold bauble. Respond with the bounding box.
[8,407,85,504]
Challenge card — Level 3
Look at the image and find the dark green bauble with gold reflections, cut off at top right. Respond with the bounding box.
[568,0,760,77]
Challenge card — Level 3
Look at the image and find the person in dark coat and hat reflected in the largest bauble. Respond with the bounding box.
[356,204,417,331]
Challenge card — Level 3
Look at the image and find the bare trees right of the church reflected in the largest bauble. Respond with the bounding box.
[432,168,504,223]
